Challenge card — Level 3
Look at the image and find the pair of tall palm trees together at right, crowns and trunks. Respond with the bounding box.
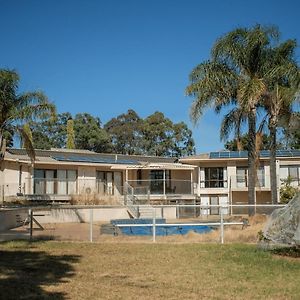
[186,25,300,214]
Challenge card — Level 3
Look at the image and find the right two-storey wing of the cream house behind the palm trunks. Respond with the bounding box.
[180,150,300,214]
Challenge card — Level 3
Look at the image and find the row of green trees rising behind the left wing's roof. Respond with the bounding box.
[30,110,195,157]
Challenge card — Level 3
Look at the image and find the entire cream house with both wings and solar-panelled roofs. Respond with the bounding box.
[0,149,300,216]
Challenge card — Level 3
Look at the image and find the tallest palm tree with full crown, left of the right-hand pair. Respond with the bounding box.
[186,25,278,215]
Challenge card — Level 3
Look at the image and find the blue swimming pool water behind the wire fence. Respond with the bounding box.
[111,219,212,236]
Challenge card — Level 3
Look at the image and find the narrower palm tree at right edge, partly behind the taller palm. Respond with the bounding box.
[263,40,300,204]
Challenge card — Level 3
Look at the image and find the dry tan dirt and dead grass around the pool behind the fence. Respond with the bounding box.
[5,215,267,243]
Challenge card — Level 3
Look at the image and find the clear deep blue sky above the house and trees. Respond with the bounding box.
[0,0,300,153]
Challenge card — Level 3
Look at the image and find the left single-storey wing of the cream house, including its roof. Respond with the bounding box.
[0,149,196,203]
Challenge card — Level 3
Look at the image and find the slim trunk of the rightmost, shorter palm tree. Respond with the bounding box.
[269,120,278,204]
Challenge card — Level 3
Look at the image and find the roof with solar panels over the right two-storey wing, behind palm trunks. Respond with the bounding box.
[180,149,300,161]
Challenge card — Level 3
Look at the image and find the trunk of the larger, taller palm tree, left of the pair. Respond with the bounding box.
[248,108,256,216]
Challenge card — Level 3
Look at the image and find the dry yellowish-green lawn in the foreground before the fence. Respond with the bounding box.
[0,241,300,299]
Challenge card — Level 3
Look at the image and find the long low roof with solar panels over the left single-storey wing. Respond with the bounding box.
[6,148,177,165]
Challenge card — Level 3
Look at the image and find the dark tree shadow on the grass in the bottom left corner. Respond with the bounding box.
[0,243,80,299]
